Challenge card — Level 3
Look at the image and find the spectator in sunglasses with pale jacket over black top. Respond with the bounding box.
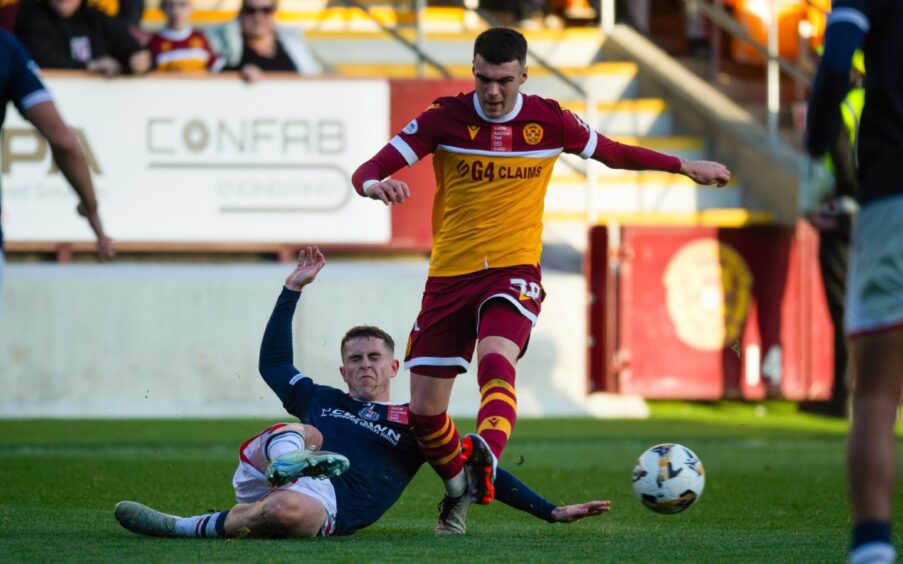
[205,0,321,82]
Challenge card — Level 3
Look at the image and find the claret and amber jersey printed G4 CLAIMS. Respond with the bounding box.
[390,92,597,276]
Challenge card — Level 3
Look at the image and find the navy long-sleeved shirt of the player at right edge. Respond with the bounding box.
[807,0,903,204]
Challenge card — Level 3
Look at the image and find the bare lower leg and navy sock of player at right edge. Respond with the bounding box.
[847,330,903,562]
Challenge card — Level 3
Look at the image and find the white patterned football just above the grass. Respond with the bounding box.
[633,444,705,513]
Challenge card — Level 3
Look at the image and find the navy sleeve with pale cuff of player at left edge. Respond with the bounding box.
[0,30,51,247]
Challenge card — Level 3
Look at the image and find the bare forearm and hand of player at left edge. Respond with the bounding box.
[24,101,116,261]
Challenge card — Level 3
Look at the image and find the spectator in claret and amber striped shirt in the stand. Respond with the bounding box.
[148,0,223,72]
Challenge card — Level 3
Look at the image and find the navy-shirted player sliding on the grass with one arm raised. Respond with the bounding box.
[114,247,610,537]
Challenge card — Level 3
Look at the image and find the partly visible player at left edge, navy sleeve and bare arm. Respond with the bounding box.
[0,30,115,288]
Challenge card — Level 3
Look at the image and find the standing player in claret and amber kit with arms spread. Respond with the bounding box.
[353,28,730,528]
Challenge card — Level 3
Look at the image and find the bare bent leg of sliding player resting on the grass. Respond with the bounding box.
[225,490,327,538]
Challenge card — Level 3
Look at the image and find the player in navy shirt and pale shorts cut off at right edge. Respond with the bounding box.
[807,0,903,564]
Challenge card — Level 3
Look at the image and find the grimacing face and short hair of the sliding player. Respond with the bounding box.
[339,337,399,401]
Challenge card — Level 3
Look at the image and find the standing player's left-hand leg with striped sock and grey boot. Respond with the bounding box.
[409,367,470,535]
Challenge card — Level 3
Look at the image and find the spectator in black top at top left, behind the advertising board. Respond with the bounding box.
[16,0,151,76]
